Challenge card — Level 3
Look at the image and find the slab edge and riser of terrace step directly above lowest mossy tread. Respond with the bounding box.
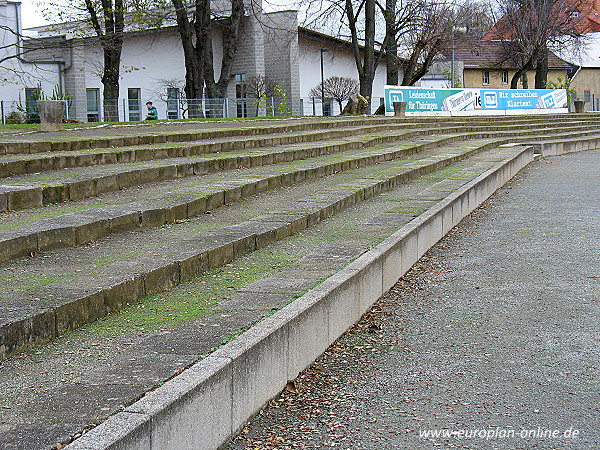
[0,139,514,356]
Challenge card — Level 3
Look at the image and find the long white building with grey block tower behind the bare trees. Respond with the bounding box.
[0,0,385,121]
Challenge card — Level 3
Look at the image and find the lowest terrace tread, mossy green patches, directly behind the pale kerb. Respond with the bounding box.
[0,143,540,448]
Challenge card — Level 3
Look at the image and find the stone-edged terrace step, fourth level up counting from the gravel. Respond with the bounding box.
[0,124,449,211]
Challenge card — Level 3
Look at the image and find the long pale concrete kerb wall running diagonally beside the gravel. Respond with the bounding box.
[67,142,534,450]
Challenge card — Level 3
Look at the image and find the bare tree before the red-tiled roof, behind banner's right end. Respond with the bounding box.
[486,0,591,89]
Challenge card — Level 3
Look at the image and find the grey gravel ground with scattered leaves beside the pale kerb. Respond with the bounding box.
[228,150,600,449]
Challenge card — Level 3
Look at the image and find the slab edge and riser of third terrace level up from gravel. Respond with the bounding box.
[0,136,501,262]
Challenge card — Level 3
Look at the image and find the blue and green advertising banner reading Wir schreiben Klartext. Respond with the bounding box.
[385,86,568,115]
